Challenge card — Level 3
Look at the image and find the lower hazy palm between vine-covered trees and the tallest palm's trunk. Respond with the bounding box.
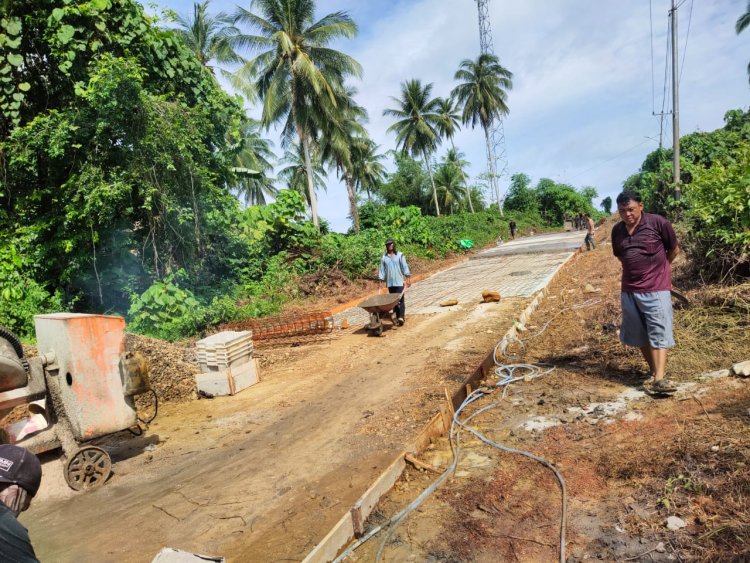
[232,118,278,205]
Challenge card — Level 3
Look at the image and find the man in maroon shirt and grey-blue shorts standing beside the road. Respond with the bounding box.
[612,191,678,393]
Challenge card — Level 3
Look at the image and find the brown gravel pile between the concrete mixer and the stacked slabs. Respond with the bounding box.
[125,334,200,402]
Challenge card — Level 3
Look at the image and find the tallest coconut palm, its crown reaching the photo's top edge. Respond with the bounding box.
[233,0,362,226]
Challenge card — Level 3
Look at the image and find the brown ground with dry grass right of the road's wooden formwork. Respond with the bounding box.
[351,241,750,562]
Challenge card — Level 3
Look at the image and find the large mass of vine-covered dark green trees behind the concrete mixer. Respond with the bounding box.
[0,0,242,333]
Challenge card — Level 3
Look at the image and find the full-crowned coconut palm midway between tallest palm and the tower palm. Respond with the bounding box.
[383,79,440,217]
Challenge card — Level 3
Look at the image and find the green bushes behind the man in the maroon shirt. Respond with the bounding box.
[624,110,750,277]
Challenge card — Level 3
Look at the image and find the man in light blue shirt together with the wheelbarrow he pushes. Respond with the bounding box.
[359,239,411,336]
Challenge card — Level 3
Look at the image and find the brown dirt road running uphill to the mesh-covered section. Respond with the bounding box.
[27,234,580,562]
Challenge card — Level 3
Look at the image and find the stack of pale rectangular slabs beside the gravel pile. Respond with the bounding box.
[195,330,260,397]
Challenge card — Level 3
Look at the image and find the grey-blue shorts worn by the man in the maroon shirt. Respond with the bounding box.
[620,291,674,348]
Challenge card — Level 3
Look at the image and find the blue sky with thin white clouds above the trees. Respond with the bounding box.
[148,0,750,232]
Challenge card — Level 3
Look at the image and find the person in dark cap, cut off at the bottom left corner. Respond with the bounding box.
[0,444,42,563]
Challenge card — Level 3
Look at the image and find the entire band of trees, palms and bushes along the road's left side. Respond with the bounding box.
[0,0,595,339]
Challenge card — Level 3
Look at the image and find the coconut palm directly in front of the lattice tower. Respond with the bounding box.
[451,53,513,213]
